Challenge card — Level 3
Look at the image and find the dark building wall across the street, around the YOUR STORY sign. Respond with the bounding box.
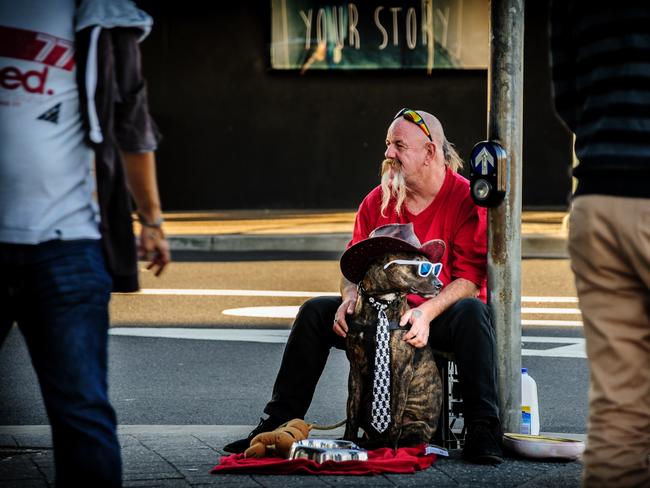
[138,0,572,210]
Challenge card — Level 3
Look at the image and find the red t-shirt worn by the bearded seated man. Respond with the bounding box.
[348,168,487,306]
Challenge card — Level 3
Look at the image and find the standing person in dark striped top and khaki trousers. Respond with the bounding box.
[550,0,650,487]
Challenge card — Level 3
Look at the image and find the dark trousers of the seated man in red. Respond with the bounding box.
[264,297,499,422]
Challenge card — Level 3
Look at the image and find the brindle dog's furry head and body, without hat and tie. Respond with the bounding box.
[344,252,442,449]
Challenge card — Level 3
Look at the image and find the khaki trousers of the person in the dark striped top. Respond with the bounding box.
[569,195,650,488]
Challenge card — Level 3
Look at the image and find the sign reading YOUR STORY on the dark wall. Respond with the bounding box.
[271,0,489,73]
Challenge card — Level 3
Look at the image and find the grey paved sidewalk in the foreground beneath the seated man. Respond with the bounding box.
[0,425,582,488]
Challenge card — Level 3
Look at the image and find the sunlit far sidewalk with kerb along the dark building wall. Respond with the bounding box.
[153,210,568,258]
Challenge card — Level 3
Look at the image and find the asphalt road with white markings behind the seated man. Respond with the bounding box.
[0,255,588,433]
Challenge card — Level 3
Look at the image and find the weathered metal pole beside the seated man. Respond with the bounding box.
[488,0,524,432]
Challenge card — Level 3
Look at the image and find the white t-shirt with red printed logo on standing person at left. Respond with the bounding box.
[0,0,100,244]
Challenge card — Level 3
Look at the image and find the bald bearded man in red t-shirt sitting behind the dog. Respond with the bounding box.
[224,109,503,464]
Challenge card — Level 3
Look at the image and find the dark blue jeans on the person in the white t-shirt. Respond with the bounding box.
[0,240,122,487]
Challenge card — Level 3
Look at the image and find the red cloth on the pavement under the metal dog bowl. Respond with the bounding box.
[210,444,436,475]
